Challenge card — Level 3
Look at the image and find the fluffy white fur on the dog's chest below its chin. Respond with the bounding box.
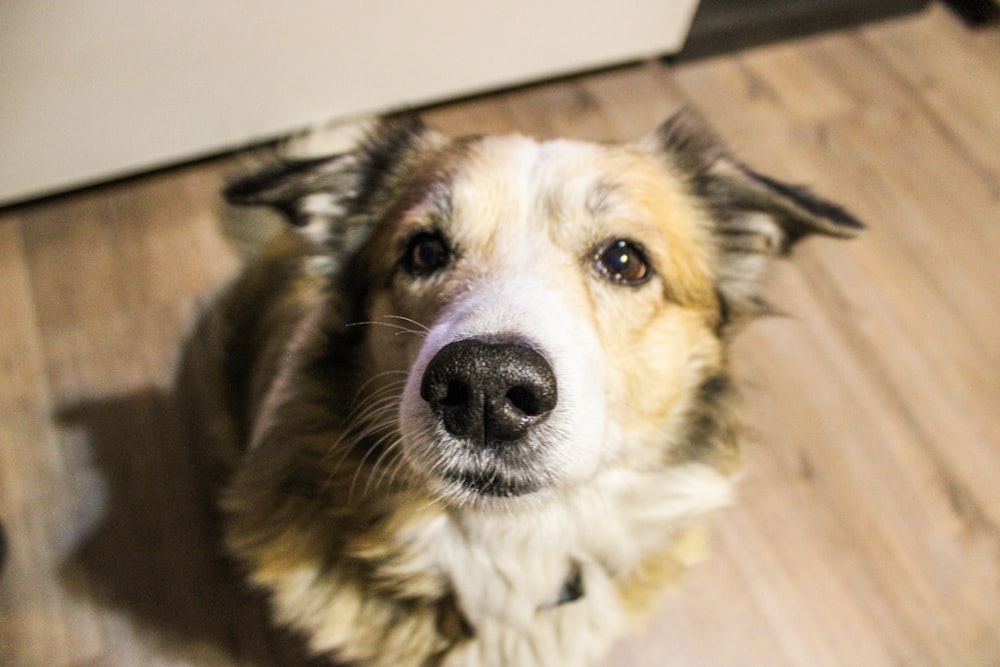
[380,464,731,667]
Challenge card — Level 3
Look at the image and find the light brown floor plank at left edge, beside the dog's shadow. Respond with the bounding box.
[0,215,102,666]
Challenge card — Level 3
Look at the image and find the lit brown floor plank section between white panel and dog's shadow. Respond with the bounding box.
[23,166,235,403]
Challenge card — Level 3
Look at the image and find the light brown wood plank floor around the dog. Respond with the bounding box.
[0,6,1000,667]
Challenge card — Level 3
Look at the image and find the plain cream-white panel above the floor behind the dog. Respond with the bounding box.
[0,0,697,204]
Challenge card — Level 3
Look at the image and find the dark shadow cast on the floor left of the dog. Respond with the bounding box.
[57,388,329,667]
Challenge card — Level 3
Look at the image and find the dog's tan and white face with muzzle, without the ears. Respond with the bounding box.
[360,137,720,501]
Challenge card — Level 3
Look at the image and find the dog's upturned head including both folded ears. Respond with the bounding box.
[228,116,862,503]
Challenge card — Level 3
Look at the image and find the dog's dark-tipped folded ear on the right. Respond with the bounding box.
[642,111,864,317]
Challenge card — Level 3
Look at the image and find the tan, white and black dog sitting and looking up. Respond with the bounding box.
[189,112,863,667]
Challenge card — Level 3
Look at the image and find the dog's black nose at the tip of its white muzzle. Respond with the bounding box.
[420,338,556,445]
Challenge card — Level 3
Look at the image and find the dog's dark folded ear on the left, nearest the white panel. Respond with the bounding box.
[223,115,432,249]
